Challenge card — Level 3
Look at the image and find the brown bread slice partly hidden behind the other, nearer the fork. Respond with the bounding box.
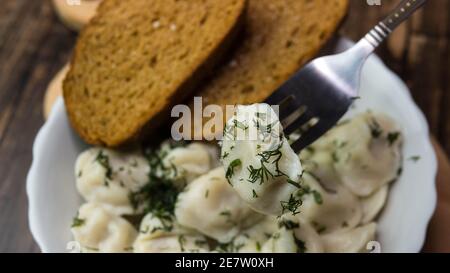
[192,0,348,136]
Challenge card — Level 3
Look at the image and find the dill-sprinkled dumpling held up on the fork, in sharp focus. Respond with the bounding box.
[221,104,303,216]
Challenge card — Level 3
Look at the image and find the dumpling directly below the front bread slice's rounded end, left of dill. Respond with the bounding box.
[75,148,150,215]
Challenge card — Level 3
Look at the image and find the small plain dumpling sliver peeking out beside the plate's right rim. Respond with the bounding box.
[361,185,389,224]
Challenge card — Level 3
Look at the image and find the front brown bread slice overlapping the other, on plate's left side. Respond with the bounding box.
[63,0,246,146]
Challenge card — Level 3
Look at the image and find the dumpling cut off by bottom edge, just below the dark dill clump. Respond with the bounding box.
[133,213,209,253]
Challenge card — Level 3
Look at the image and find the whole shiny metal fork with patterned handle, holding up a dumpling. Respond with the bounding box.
[266,0,427,152]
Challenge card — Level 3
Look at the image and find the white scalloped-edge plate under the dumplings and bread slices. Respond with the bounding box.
[27,38,437,252]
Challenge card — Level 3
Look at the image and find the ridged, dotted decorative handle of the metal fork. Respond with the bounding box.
[364,0,427,48]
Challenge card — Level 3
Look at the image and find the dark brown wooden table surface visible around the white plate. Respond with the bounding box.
[0,0,450,252]
